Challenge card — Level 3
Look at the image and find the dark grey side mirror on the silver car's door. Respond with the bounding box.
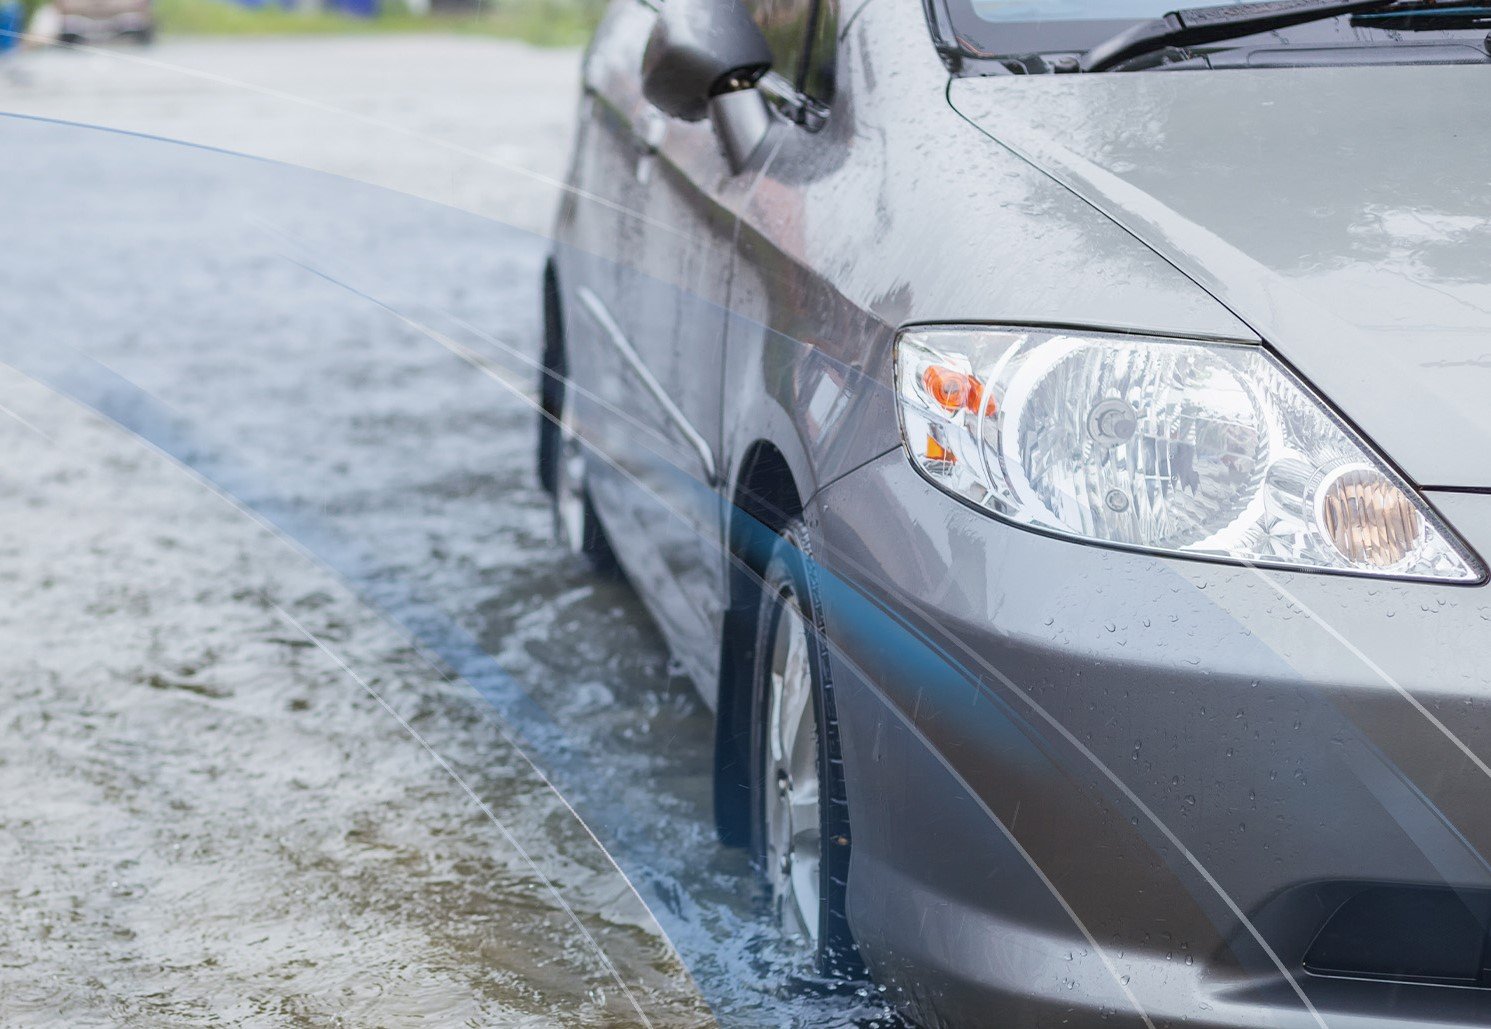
[643,0,771,172]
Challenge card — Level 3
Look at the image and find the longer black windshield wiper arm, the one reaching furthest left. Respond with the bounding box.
[1078,0,1397,72]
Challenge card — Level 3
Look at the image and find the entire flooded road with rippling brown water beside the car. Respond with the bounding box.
[0,39,889,1026]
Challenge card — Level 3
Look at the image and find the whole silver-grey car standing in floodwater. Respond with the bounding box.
[540,0,1491,1028]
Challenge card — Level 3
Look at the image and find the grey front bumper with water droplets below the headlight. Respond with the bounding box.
[810,452,1491,1026]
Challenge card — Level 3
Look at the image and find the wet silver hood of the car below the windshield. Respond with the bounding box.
[950,66,1491,486]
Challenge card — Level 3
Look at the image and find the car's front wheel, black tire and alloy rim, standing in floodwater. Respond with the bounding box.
[750,523,859,975]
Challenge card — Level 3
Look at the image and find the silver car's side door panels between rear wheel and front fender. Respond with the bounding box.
[561,0,738,697]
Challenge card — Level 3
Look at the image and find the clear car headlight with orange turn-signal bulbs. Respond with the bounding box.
[896,327,1484,582]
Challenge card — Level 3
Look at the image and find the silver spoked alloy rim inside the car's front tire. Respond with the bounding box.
[765,594,823,945]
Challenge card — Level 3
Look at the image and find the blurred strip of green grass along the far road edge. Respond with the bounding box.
[155,0,601,46]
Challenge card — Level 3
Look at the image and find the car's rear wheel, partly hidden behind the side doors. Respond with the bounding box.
[538,276,619,576]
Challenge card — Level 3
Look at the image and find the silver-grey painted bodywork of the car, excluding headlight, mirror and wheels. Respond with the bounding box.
[556,0,1491,1028]
